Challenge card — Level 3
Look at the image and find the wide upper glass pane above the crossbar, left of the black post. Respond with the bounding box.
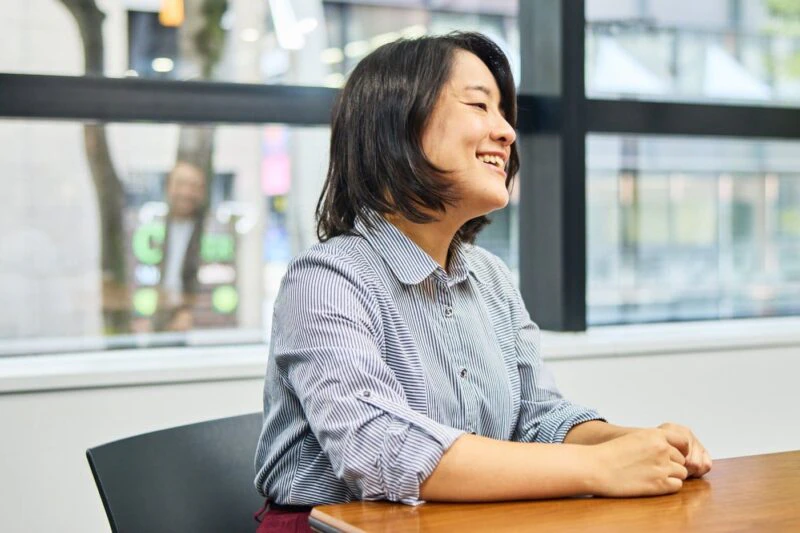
[0,0,519,87]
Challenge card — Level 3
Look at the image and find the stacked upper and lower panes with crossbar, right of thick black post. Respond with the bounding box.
[586,0,800,324]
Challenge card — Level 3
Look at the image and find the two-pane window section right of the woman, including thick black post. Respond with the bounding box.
[519,0,800,330]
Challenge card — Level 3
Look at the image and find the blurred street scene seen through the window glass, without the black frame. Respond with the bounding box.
[0,0,800,354]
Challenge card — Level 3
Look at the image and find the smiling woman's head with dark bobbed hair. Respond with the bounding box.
[318,34,519,242]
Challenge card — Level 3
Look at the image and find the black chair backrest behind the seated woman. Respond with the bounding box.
[86,413,264,533]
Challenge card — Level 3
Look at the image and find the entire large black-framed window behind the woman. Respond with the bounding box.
[0,0,800,353]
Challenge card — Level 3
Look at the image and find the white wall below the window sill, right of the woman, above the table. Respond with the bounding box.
[552,347,800,458]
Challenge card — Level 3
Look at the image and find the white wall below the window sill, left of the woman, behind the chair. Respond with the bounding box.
[0,379,262,533]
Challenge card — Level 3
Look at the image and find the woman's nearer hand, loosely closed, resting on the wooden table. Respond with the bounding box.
[586,428,689,497]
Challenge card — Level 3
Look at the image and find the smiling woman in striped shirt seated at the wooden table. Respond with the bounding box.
[256,33,711,531]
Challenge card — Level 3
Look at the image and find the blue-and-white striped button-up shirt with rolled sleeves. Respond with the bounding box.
[255,213,600,505]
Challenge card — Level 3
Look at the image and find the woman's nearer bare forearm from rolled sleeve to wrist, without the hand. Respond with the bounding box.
[420,435,593,502]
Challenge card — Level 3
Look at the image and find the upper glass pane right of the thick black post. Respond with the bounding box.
[586,0,800,106]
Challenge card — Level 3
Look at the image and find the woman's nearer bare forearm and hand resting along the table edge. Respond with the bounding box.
[420,430,687,501]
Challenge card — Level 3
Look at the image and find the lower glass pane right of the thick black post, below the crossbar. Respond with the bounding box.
[586,134,800,325]
